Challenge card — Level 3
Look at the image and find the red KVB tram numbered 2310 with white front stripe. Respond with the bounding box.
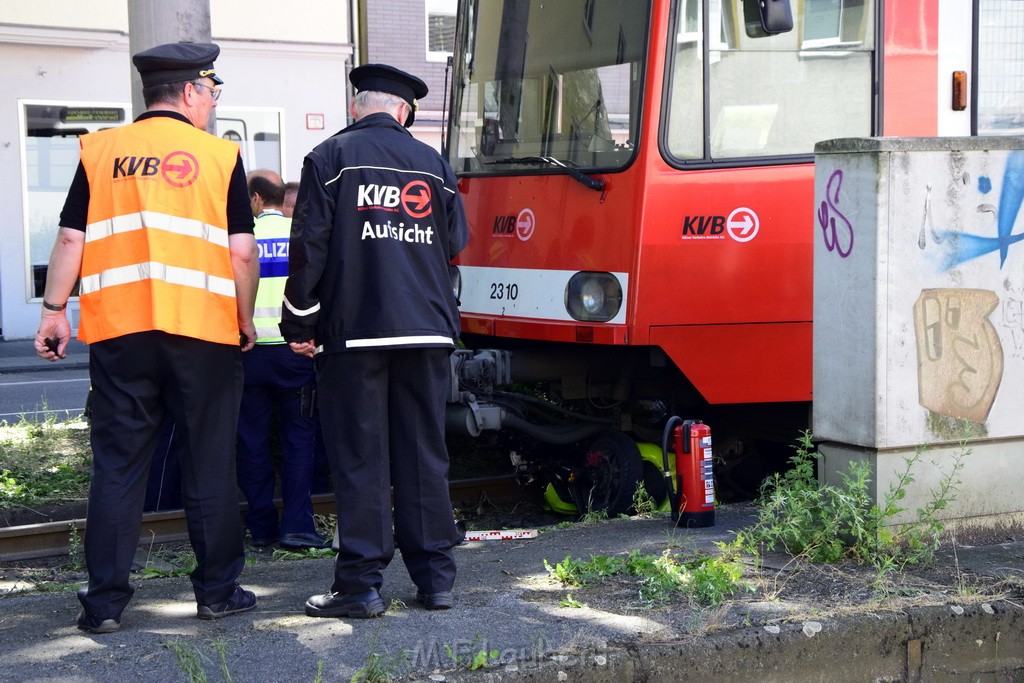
[445,0,1024,512]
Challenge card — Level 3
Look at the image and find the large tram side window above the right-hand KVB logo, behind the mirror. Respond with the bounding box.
[665,0,874,161]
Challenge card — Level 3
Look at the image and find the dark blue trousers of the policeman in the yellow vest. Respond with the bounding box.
[236,344,316,540]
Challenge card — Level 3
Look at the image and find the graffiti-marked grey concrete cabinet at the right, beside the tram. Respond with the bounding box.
[813,137,1024,527]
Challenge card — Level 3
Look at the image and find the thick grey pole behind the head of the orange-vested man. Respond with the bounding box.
[126,0,217,132]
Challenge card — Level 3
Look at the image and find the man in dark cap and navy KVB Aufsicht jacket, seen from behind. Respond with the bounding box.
[281,65,469,617]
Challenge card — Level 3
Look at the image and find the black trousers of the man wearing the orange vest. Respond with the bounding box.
[79,332,245,618]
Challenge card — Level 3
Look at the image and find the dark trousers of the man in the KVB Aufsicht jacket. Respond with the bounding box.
[316,348,456,593]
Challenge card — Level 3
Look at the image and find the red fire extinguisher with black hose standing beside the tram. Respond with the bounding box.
[662,417,715,527]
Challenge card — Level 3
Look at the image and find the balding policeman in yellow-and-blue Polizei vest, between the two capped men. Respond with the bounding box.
[236,169,328,549]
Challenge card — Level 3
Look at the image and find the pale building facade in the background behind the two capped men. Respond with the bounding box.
[0,0,354,340]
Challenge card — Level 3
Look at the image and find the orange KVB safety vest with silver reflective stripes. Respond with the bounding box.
[78,117,239,345]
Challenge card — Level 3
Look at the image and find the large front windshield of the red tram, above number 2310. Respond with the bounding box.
[449,0,650,173]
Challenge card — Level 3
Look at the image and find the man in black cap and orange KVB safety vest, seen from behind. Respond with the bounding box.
[35,43,259,633]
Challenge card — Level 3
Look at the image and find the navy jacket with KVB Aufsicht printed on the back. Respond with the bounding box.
[281,114,469,353]
